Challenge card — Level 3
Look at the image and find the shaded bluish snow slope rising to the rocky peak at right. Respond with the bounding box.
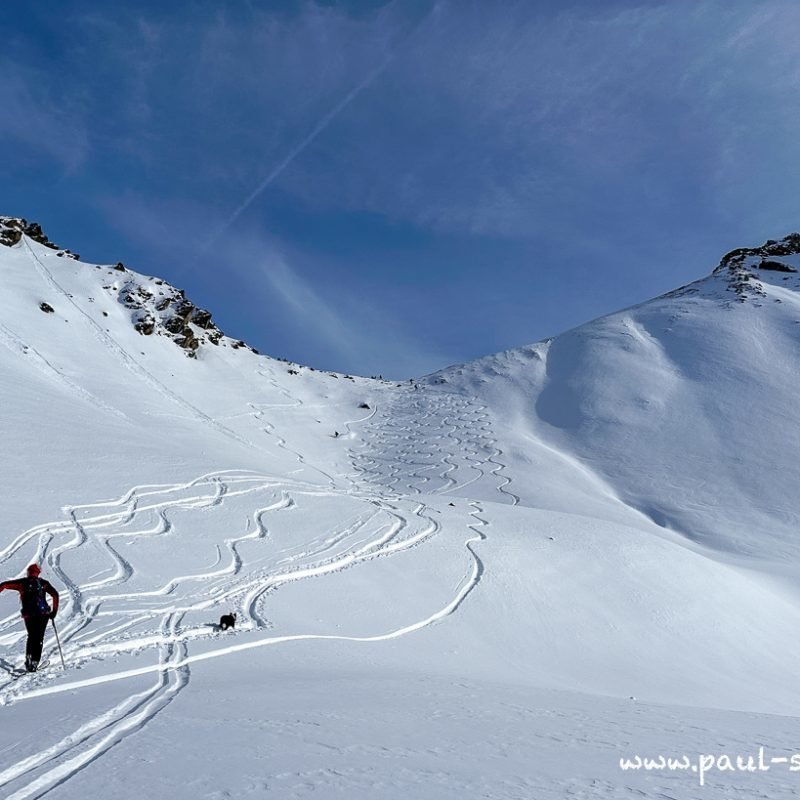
[430,234,800,563]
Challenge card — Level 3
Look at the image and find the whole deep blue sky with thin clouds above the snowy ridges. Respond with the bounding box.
[0,0,800,378]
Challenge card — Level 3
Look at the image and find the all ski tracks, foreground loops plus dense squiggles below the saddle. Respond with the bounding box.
[0,374,519,800]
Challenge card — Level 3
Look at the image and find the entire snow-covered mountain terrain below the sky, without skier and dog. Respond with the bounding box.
[0,218,800,799]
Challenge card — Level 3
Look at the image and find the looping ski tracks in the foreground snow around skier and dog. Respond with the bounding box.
[0,473,483,800]
